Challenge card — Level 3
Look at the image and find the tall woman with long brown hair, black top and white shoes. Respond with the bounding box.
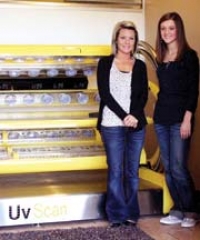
[154,12,199,227]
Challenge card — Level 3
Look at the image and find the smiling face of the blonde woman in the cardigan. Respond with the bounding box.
[117,29,136,54]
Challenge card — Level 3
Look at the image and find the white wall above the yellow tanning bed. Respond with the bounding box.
[0,3,145,44]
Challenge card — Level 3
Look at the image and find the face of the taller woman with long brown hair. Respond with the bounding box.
[160,20,177,44]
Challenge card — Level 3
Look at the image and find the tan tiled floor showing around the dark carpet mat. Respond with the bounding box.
[0,217,200,240]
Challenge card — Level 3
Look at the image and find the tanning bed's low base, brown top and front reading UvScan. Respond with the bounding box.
[0,170,162,227]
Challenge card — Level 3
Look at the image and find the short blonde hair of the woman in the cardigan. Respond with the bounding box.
[111,21,139,56]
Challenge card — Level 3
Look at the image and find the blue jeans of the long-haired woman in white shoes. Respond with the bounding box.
[155,123,195,217]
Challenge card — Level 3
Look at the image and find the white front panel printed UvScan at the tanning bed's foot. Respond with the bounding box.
[0,194,103,226]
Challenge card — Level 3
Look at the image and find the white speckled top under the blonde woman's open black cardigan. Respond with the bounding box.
[101,63,132,127]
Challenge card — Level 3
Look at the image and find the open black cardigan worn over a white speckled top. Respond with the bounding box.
[97,55,148,130]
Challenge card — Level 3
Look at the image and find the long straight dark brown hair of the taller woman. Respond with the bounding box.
[156,12,190,62]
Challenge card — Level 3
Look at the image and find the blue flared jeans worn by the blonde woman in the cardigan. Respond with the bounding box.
[101,126,145,222]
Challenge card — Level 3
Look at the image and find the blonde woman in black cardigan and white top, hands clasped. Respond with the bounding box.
[97,21,148,227]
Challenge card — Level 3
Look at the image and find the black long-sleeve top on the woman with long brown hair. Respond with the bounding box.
[154,49,199,125]
